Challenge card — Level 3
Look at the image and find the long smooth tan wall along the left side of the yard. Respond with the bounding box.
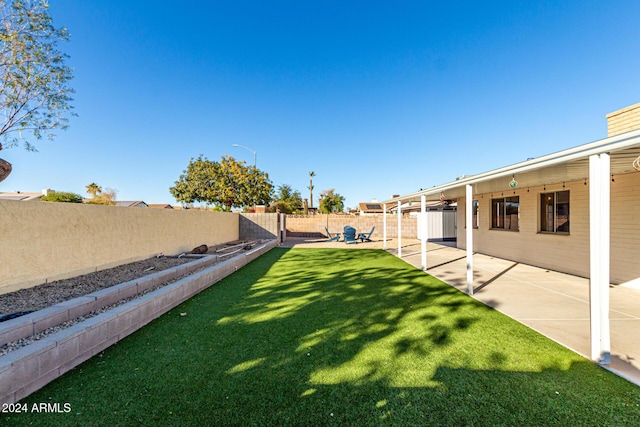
[0,200,239,293]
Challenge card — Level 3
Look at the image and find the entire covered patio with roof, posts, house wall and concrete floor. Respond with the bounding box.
[383,125,640,380]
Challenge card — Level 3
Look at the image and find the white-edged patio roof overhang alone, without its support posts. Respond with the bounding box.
[382,130,640,204]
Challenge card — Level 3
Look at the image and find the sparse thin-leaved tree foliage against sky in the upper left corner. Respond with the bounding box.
[0,0,74,151]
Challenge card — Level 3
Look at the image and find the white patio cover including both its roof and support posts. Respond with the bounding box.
[383,122,640,364]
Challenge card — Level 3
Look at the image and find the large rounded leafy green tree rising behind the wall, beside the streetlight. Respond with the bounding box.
[169,155,273,211]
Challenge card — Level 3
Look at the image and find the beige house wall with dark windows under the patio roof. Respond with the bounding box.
[457,173,640,284]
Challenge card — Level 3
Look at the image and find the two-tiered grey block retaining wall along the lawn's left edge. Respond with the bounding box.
[0,240,278,404]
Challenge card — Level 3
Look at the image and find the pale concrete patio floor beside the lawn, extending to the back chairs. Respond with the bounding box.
[283,239,640,385]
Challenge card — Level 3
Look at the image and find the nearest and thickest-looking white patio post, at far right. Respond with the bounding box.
[589,153,611,364]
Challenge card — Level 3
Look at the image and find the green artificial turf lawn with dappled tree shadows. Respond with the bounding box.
[6,248,640,426]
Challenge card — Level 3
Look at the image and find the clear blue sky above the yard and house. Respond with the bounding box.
[0,0,640,207]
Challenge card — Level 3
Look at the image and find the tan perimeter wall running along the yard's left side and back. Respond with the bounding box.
[0,206,417,294]
